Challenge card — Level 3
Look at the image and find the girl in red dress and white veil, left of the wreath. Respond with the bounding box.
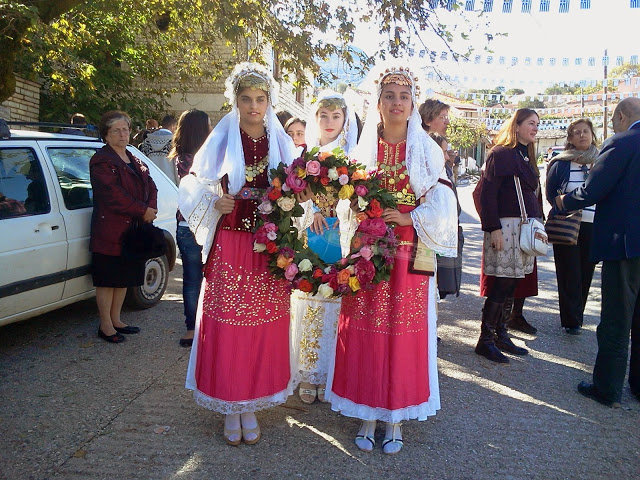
[179,63,295,445]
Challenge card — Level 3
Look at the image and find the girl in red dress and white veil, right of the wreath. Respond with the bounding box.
[327,67,458,454]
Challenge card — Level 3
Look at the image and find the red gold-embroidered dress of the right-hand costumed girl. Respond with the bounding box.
[327,139,440,423]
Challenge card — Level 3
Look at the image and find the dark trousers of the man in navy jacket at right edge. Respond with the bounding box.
[593,257,640,402]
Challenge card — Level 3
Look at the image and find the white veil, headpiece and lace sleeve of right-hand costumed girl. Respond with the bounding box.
[352,67,458,257]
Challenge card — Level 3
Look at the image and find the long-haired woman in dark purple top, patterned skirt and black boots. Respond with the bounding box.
[475,108,542,363]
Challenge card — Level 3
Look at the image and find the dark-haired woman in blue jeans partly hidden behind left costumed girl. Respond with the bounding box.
[169,109,211,347]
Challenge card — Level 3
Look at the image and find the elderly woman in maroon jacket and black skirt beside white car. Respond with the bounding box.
[89,111,158,343]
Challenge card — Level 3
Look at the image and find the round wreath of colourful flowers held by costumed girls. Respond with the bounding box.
[254,147,398,298]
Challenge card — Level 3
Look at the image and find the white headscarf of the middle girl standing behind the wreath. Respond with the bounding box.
[305,90,358,155]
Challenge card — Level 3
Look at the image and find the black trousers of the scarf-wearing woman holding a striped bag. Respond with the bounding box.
[553,222,596,328]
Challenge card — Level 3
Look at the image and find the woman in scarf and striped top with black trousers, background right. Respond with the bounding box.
[546,118,598,335]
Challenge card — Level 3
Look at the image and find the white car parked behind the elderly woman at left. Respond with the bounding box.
[0,130,178,326]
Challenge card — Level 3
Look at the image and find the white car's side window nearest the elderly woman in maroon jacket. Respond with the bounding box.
[48,147,96,210]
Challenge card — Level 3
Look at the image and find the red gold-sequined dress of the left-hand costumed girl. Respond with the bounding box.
[192,131,294,414]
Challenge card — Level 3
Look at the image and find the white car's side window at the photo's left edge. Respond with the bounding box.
[0,148,51,219]
